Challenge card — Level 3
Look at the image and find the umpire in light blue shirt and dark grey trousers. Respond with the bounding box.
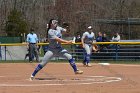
[27,28,39,62]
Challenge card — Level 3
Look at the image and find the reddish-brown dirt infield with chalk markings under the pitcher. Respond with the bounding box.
[0,63,140,93]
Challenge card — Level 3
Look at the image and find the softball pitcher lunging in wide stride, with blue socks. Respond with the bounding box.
[30,19,83,80]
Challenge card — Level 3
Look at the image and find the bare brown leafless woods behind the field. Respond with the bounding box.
[0,0,140,39]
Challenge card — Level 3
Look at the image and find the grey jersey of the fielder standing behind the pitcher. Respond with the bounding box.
[82,32,95,44]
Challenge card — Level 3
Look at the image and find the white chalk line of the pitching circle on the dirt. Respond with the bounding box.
[0,76,122,87]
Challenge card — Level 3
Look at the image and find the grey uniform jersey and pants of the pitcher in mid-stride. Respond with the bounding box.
[41,29,72,66]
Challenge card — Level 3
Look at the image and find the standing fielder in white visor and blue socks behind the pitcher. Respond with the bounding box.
[81,26,95,67]
